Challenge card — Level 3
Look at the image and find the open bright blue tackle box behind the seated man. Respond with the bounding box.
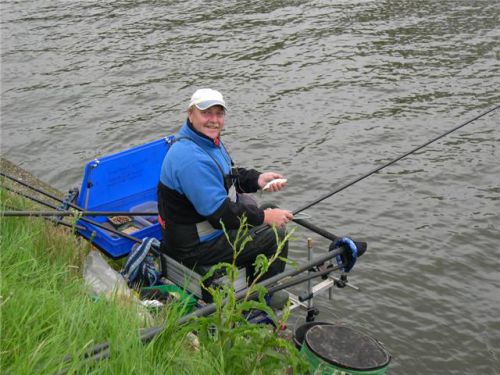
[77,138,169,258]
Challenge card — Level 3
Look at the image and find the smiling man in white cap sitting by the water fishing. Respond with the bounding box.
[158,89,293,288]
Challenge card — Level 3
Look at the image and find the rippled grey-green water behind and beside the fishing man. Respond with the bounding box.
[1,0,500,374]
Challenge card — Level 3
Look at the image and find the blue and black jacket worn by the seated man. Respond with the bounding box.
[158,120,264,251]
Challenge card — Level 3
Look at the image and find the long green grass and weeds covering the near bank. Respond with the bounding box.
[0,189,304,375]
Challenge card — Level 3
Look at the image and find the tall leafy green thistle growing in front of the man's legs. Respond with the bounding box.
[190,218,307,374]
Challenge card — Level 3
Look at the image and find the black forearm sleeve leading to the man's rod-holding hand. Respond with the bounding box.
[207,198,264,229]
